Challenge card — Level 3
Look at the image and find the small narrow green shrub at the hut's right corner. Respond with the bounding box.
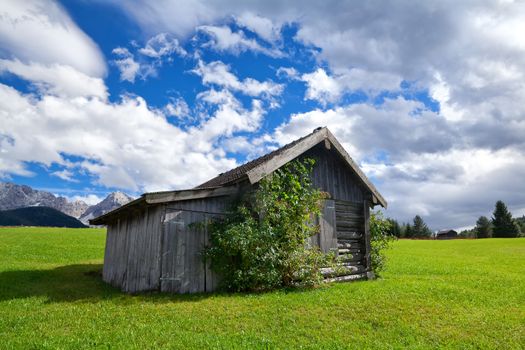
[370,211,396,275]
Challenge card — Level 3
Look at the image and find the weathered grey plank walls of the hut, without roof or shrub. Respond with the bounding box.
[103,139,371,293]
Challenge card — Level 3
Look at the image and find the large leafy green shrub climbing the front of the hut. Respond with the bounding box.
[204,159,334,291]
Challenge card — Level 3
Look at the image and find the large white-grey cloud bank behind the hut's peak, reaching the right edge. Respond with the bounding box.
[272,98,525,229]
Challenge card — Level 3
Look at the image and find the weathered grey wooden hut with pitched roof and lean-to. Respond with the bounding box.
[90,128,387,293]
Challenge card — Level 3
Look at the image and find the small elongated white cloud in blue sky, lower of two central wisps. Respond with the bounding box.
[192,60,284,97]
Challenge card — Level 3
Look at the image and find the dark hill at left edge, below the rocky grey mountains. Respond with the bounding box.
[0,207,86,228]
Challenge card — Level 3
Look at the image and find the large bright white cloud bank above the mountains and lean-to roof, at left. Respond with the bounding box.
[0,84,264,191]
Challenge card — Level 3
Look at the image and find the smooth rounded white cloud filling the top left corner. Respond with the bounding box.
[0,0,106,77]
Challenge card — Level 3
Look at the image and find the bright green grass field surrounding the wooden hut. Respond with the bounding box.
[0,228,525,349]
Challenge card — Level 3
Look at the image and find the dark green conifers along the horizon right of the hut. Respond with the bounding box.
[387,201,525,238]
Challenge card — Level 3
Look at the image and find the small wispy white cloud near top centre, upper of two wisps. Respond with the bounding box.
[197,25,283,57]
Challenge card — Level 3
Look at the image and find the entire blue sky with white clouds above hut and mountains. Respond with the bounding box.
[0,0,525,229]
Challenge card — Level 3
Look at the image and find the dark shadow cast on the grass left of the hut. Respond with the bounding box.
[0,264,210,303]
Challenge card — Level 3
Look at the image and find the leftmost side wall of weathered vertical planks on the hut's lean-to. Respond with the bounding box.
[102,205,164,293]
